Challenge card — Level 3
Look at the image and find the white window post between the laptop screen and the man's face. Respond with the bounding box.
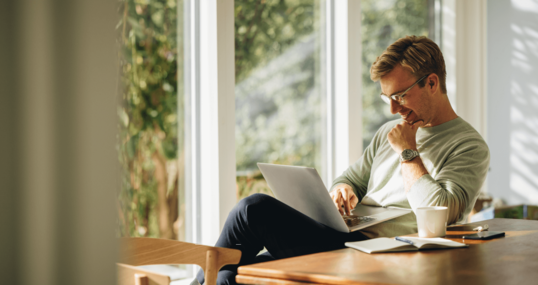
[322,0,363,185]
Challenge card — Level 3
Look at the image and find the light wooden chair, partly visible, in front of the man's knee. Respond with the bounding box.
[117,238,241,285]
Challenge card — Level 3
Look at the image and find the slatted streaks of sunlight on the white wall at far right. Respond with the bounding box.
[509,0,538,204]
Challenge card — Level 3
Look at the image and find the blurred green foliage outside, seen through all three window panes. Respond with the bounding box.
[117,0,428,239]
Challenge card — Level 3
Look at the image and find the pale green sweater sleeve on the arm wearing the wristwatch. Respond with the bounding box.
[407,140,489,224]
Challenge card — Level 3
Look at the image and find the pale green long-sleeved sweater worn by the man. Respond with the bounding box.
[331,117,489,238]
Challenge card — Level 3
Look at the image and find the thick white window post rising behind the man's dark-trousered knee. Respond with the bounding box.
[184,0,236,245]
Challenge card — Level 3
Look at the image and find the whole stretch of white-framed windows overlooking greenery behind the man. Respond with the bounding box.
[117,0,433,255]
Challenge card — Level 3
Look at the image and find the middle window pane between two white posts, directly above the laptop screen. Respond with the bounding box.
[235,0,323,199]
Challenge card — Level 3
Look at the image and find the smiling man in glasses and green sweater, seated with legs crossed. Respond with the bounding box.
[193,36,489,284]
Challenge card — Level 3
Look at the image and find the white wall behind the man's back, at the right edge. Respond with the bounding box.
[487,0,538,204]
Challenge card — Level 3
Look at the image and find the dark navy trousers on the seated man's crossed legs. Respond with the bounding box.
[196,194,367,284]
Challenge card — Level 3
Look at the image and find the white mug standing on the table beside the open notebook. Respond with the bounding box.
[416,207,448,238]
